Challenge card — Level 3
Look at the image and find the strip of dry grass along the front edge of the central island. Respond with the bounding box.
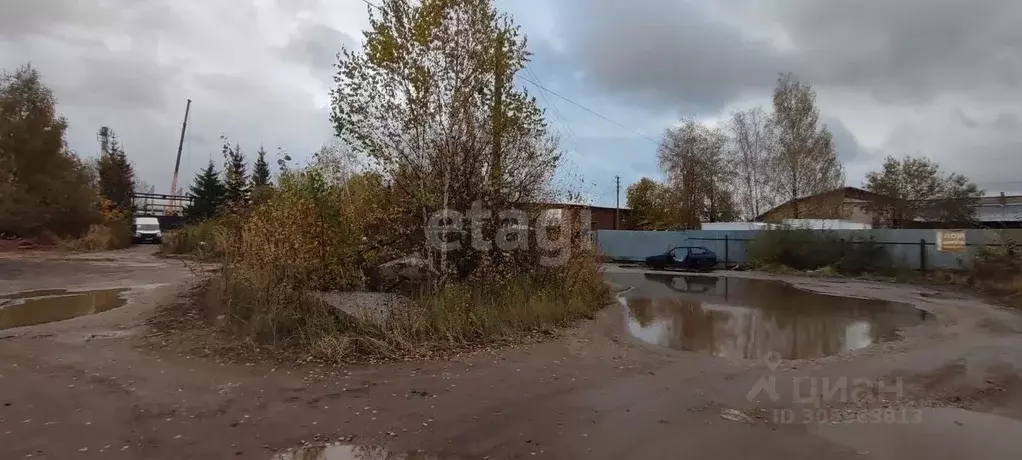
[186,251,610,362]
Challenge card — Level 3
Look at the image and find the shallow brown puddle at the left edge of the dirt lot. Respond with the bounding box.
[0,288,128,330]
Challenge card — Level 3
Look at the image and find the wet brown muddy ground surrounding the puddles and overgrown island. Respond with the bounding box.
[0,246,1022,459]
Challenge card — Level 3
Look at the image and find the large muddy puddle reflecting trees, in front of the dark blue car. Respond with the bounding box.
[620,274,928,359]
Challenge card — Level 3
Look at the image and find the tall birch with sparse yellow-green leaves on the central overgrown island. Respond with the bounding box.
[331,0,560,273]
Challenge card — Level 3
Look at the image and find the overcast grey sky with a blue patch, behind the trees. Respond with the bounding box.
[0,0,1022,205]
